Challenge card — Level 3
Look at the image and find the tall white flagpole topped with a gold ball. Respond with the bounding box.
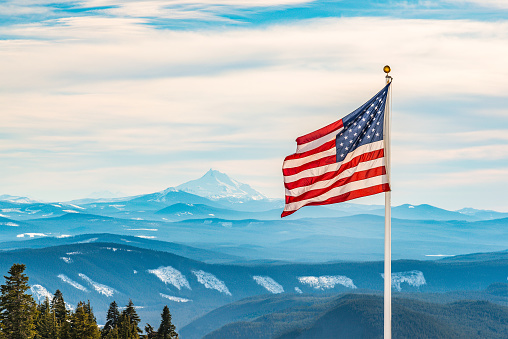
[383,66,392,339]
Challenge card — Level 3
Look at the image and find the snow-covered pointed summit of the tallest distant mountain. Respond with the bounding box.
[176,169,266,200]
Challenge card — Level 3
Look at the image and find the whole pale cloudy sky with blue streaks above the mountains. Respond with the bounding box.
[0,0,508,212]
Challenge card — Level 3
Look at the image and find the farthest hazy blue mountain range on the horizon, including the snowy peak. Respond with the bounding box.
[0,169,508,221]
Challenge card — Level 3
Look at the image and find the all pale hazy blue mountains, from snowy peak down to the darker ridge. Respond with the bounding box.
[0,170,508,262]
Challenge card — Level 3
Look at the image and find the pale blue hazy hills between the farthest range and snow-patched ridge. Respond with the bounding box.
[0,213,508,262]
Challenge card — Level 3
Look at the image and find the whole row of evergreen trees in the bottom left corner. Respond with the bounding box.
[0,264,178,339]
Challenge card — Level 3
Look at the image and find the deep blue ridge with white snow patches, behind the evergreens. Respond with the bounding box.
[0,239,508,334]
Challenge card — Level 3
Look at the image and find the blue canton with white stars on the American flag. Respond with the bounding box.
[335,84,390,162]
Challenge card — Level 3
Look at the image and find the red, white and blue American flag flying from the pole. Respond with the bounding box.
[281,83,390,217]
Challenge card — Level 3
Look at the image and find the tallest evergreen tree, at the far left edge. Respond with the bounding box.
[0,264,37,339]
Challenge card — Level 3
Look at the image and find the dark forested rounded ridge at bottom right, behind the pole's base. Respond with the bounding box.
[199,294,508,339]
